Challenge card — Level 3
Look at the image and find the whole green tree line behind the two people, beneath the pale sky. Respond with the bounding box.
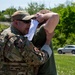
[0,2,75,50]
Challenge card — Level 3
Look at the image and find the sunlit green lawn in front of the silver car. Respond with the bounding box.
[55,54,75,75]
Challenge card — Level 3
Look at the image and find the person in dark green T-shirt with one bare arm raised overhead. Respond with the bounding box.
[32,9,59,75]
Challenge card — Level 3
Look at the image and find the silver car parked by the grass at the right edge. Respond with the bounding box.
[57,45,75,54]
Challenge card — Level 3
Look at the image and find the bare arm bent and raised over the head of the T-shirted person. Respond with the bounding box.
[36,12,59,33]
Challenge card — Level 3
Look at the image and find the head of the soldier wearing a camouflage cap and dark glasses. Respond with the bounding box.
[11,11,34,34]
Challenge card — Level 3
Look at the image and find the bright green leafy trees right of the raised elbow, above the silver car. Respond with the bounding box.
[52,3,75,49]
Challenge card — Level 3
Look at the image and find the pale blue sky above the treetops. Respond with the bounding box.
[0,0,75,11]
